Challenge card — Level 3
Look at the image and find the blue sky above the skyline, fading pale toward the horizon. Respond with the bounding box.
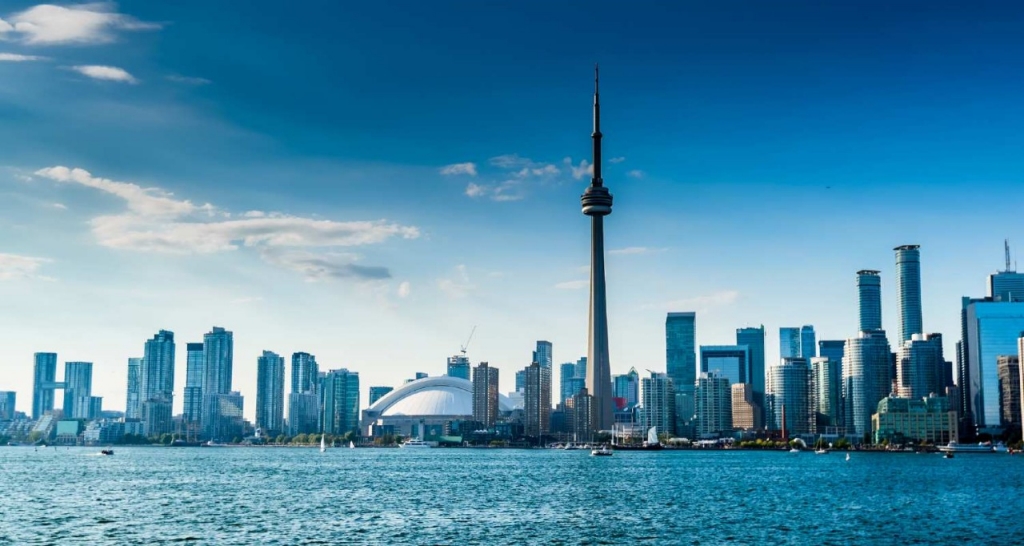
[0,1,1024,415]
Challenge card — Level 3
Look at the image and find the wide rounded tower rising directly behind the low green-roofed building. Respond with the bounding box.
[896,334,947,400]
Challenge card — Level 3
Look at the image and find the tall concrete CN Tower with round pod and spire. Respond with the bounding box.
[580,66,613,430]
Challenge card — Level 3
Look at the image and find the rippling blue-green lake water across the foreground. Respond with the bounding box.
[0,448,1024,545]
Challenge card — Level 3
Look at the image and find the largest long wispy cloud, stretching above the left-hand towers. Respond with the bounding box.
[35,166,420,281]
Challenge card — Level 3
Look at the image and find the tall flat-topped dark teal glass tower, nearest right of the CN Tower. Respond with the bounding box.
[667,312,697,434]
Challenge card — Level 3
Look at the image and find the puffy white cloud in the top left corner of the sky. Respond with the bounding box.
[0,3,160,45]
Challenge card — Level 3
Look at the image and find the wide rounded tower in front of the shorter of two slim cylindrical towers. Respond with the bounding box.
[843,330,892,437]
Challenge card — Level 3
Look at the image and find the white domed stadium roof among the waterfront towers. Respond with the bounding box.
[360,375,513,437]
